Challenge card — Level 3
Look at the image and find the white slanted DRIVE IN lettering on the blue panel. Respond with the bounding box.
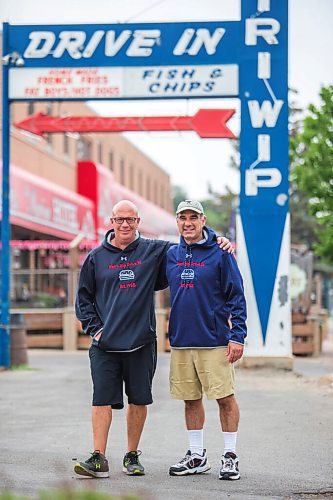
[23,27,226,59]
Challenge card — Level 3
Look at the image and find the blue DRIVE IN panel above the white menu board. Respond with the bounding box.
[9,21,241,68]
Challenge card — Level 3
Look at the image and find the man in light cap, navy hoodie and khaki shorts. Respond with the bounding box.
[167,200,246,480]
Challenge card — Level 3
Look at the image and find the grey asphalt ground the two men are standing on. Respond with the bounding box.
[0,342,333,500]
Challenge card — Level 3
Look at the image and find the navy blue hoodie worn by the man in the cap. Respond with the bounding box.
[167,227,246,348]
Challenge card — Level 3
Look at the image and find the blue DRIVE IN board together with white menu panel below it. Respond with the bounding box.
[9,22,241,99]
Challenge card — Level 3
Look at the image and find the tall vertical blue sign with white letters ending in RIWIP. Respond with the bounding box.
[237,0,291,356]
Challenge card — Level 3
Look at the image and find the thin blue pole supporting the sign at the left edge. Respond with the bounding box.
[0,23,10,368]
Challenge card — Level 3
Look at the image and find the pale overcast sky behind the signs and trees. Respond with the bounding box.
[0,0,333,198]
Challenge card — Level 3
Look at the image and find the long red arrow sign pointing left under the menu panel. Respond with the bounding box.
[15,109,236,139]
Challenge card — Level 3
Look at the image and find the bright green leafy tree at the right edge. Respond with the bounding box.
[290,85,333,262]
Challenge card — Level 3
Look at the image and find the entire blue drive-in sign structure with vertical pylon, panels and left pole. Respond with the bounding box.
[0,0,291,368]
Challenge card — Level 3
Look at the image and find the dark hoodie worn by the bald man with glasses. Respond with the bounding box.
[76,231,169,351]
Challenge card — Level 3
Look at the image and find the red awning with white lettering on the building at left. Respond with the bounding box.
[0,165,96,240]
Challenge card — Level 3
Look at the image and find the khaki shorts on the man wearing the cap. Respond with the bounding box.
[169,347,235,401]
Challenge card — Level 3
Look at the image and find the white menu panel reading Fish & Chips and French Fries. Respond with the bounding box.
[9,64,238,99]
